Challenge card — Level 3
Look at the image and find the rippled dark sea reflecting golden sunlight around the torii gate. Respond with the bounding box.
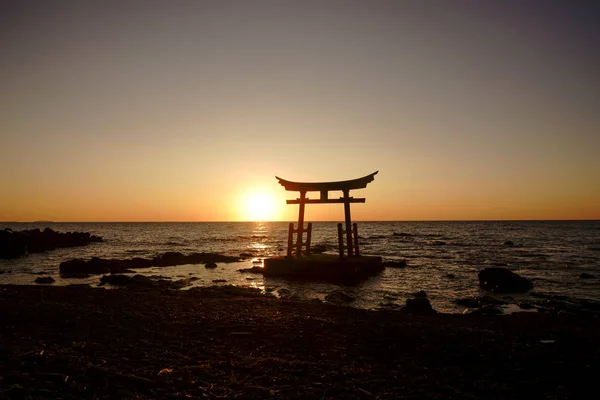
[0,221,600,313]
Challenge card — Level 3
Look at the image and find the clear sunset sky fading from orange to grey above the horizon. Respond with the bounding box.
[0,0,600,221]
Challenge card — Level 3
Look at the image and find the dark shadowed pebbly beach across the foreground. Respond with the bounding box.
[0,286,600,399]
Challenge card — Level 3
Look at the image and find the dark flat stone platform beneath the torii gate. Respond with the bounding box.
[263,254,384,285]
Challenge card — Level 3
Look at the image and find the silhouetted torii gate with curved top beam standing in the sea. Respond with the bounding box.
[275,171,379,257]
